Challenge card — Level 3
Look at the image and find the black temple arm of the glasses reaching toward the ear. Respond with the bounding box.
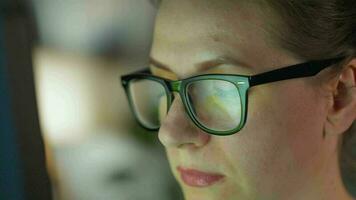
[249,57,344,87]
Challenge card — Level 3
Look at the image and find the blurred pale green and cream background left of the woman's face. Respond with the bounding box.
[0,0,183,200]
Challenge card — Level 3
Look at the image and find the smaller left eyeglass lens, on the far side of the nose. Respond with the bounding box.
[129,79,167,129]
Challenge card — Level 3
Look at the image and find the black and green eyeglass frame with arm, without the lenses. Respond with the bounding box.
[121,57,345,136]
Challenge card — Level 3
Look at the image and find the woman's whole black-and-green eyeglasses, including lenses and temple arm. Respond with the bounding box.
[121,58,343,136]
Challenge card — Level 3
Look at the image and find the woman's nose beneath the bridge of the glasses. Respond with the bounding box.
[158,95,211,148]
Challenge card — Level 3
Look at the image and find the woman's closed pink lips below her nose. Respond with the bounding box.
[177,167,225,187]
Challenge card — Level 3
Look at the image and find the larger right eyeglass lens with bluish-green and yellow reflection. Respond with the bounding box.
[187,80,242,131]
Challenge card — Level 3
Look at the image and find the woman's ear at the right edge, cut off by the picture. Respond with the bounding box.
[324,58,356,135]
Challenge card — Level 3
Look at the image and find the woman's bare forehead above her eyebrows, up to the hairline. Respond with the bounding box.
[151,0,294,76]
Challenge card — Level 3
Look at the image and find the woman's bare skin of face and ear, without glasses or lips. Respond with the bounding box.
[151,0,356,200]
